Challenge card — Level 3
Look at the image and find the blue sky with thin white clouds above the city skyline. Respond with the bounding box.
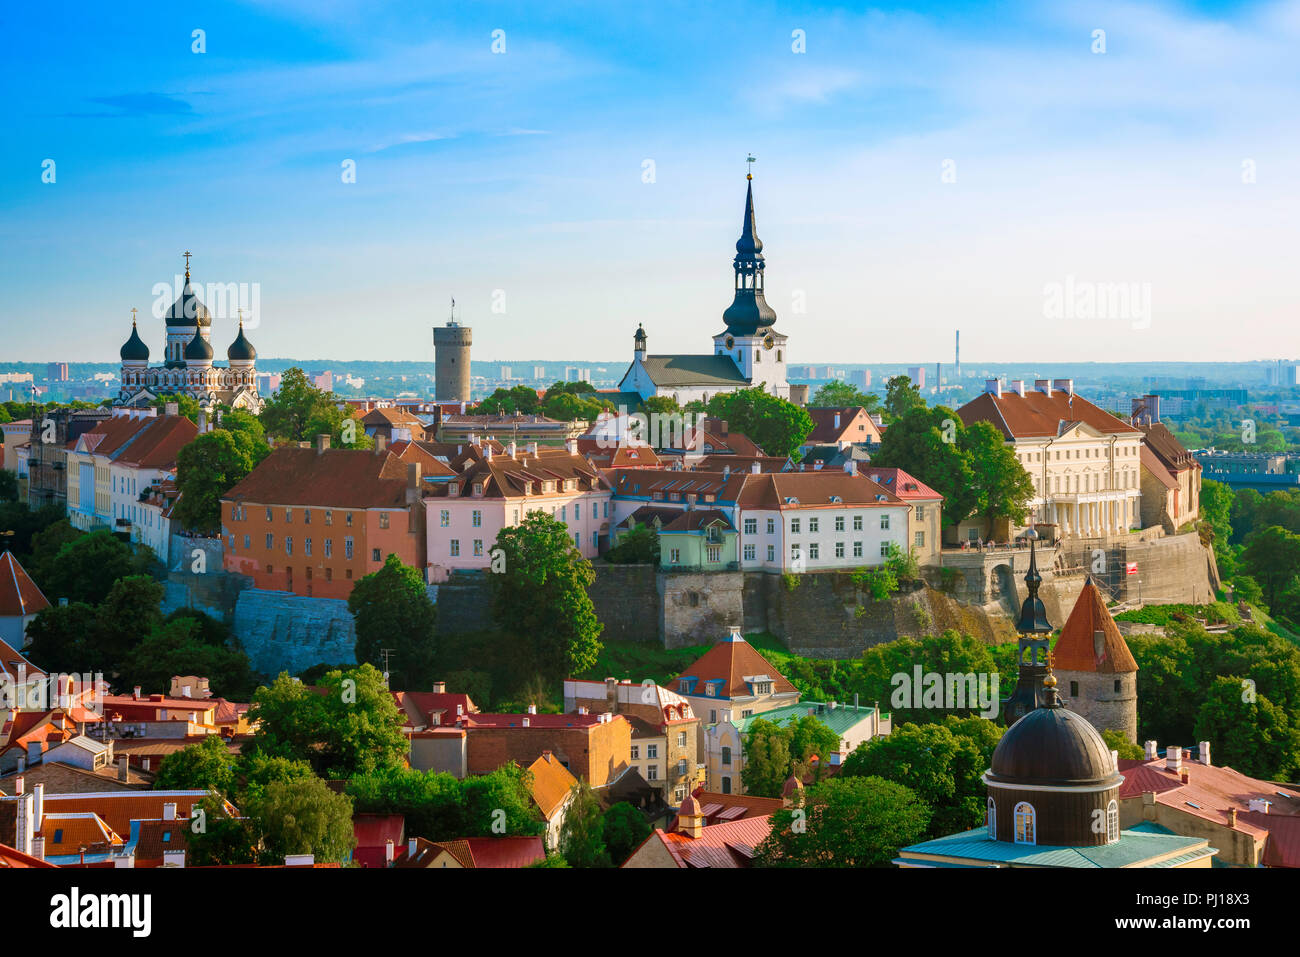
[0,0,1300,364]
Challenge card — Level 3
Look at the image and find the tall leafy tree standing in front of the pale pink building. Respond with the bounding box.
[488,510,605,679]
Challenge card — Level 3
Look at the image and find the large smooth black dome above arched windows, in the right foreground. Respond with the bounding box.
[988,706,1123,787]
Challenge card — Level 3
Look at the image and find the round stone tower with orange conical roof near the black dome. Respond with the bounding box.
[1052,577,1138,744]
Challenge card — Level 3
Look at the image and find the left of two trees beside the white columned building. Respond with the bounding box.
[871,406,979,525]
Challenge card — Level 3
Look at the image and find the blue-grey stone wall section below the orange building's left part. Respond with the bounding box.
[231,588,356,676]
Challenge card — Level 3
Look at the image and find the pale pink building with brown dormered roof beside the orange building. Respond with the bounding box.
[424,442,611,581]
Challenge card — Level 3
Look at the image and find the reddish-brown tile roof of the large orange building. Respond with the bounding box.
[221,449,407,508]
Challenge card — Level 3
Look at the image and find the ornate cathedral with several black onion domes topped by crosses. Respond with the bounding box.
[114,252,263,415]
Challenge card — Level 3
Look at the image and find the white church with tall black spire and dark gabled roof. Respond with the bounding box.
[619,160,790,404]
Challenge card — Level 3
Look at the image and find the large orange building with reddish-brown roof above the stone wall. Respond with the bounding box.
[221,437,425,598]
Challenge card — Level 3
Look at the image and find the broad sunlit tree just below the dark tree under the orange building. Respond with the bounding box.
[248,664,408,778]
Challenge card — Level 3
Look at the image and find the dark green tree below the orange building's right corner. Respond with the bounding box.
[347,554,437,690]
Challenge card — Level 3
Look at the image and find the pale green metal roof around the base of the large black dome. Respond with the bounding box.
[900,827,1217,867]
